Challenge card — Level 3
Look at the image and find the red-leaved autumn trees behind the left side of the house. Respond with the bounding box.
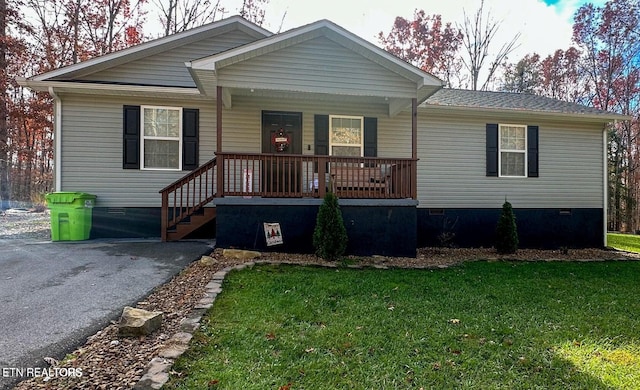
[0,0,269,209]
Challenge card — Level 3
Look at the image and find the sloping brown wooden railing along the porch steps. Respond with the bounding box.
[160,158,217,241]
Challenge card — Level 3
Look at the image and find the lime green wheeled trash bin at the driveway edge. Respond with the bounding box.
[46,192,96,241]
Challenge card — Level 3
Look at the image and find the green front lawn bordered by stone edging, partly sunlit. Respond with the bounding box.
[167,262,640,389]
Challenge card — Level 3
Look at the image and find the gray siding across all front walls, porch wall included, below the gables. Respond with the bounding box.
[61,95,603,209]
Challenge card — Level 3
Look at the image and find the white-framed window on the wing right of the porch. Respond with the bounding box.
[498,125,527,177]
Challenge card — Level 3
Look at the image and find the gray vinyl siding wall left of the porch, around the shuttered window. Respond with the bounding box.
[60,95,216,207]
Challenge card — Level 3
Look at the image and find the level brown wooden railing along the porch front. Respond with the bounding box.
[216,152,417,199]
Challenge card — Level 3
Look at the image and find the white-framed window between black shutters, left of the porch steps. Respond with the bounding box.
[140,106,182,170]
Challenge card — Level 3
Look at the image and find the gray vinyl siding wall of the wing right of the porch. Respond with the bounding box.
[418,115,604,209]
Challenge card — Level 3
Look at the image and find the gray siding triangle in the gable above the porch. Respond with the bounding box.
[218,37,416,97]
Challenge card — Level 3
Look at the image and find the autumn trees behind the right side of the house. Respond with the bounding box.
[378,0,640,232]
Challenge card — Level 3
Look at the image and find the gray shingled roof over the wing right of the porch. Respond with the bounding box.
[423,88,630,121]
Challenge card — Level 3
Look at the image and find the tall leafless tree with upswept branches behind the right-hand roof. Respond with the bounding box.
[460,0,520,91]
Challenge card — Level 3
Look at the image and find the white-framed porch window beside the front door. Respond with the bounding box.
[329,115,364,157]
